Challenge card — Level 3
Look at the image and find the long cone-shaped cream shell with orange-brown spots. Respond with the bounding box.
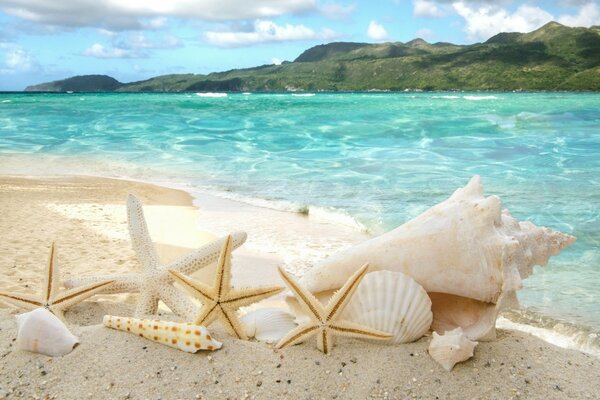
[102,315,222,353]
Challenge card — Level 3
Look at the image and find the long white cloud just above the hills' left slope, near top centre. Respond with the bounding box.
[204,20,335,47]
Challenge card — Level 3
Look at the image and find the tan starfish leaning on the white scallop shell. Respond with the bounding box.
[276,264,392,354]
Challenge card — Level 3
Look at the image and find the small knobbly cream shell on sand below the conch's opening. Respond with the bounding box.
[429,328,477,371]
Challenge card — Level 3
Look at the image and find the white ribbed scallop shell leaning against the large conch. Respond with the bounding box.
[342,271,433,344]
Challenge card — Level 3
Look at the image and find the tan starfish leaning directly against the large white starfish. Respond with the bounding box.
[169,236,283,340]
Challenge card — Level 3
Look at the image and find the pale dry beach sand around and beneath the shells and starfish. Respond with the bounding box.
[0,177,600,399]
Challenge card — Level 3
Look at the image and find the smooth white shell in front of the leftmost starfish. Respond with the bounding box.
[16,308,79,357]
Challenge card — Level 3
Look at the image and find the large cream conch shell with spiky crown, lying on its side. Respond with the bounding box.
[300,176,575,340]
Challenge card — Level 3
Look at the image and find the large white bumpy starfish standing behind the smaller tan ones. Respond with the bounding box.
[65,194,246,320]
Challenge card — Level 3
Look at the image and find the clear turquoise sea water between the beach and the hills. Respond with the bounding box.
[0,93,600,328]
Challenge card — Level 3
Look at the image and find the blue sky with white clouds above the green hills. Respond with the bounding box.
[0,0,600,90]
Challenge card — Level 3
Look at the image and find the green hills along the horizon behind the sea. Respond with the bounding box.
[26,22,600,91]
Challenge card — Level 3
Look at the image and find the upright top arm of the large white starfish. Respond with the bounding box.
[127,194,158,270]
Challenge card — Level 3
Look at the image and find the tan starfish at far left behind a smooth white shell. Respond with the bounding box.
[0,242,113,320]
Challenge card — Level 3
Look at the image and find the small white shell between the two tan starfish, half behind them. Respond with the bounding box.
[241,308,296,343]
